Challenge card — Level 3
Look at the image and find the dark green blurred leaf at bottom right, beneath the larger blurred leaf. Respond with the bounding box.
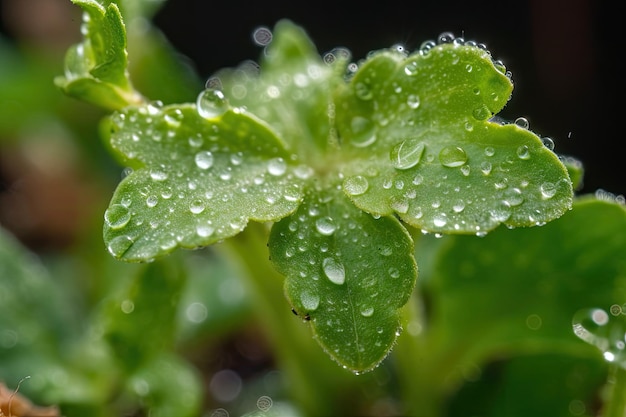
[446,354,607,417]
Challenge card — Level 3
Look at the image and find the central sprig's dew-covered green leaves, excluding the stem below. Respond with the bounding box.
[80,6,572,372]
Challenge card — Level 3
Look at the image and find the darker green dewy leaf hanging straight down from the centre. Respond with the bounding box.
[269,190,417,372]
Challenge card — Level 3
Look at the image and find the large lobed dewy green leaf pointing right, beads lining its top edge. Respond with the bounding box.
[336,43,573,234]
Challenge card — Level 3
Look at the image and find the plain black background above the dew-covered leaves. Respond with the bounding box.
[150,0,626,194]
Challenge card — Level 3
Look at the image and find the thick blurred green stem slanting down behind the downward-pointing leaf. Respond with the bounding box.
[216,223,354,416]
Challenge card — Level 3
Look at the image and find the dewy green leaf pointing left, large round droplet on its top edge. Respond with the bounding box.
[104,103,304,261]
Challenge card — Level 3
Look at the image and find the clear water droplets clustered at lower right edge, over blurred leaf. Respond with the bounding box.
[572,304,626,369]
